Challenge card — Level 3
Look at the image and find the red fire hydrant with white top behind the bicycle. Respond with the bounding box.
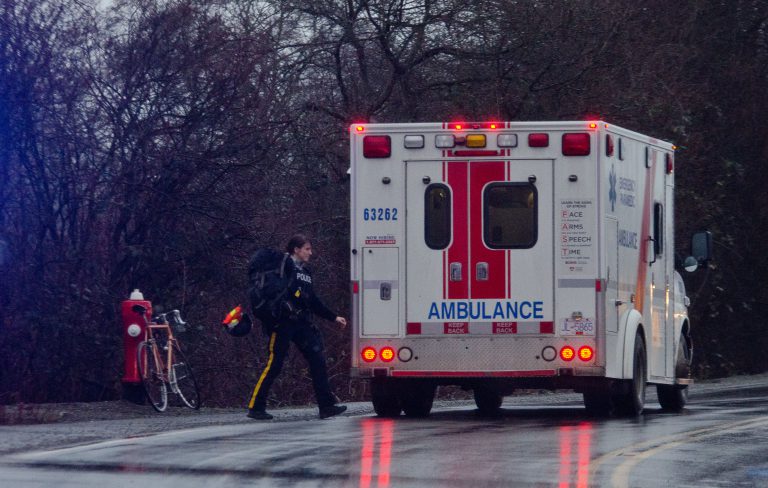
[121,289,152,403]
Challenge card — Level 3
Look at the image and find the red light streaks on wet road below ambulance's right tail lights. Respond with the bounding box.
[558,422,592,488]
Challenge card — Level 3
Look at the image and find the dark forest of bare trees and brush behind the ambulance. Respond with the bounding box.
[0,0,768,405]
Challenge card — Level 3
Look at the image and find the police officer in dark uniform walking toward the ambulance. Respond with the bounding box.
[248,234,347,420]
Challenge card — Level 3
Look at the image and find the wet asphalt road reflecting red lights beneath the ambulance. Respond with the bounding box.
[0,376,768,488]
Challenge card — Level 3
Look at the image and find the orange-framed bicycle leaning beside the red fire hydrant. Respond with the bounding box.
[132,305,200,412]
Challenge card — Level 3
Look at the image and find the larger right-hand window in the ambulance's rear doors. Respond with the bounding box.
[483,182,538,249]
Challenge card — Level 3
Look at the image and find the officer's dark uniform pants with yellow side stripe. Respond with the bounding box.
[248,323,335,411]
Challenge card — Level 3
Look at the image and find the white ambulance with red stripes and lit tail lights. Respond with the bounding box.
[350,121,712,417]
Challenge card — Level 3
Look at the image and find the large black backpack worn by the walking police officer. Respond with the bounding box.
[248,247,295,328]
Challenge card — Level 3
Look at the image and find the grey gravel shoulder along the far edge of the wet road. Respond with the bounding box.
[0,374,768,456]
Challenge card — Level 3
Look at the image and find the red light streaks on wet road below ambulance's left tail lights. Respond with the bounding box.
[360,419,395,488]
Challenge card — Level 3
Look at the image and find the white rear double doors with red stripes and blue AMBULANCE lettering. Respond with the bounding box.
[406,160,554,335]
